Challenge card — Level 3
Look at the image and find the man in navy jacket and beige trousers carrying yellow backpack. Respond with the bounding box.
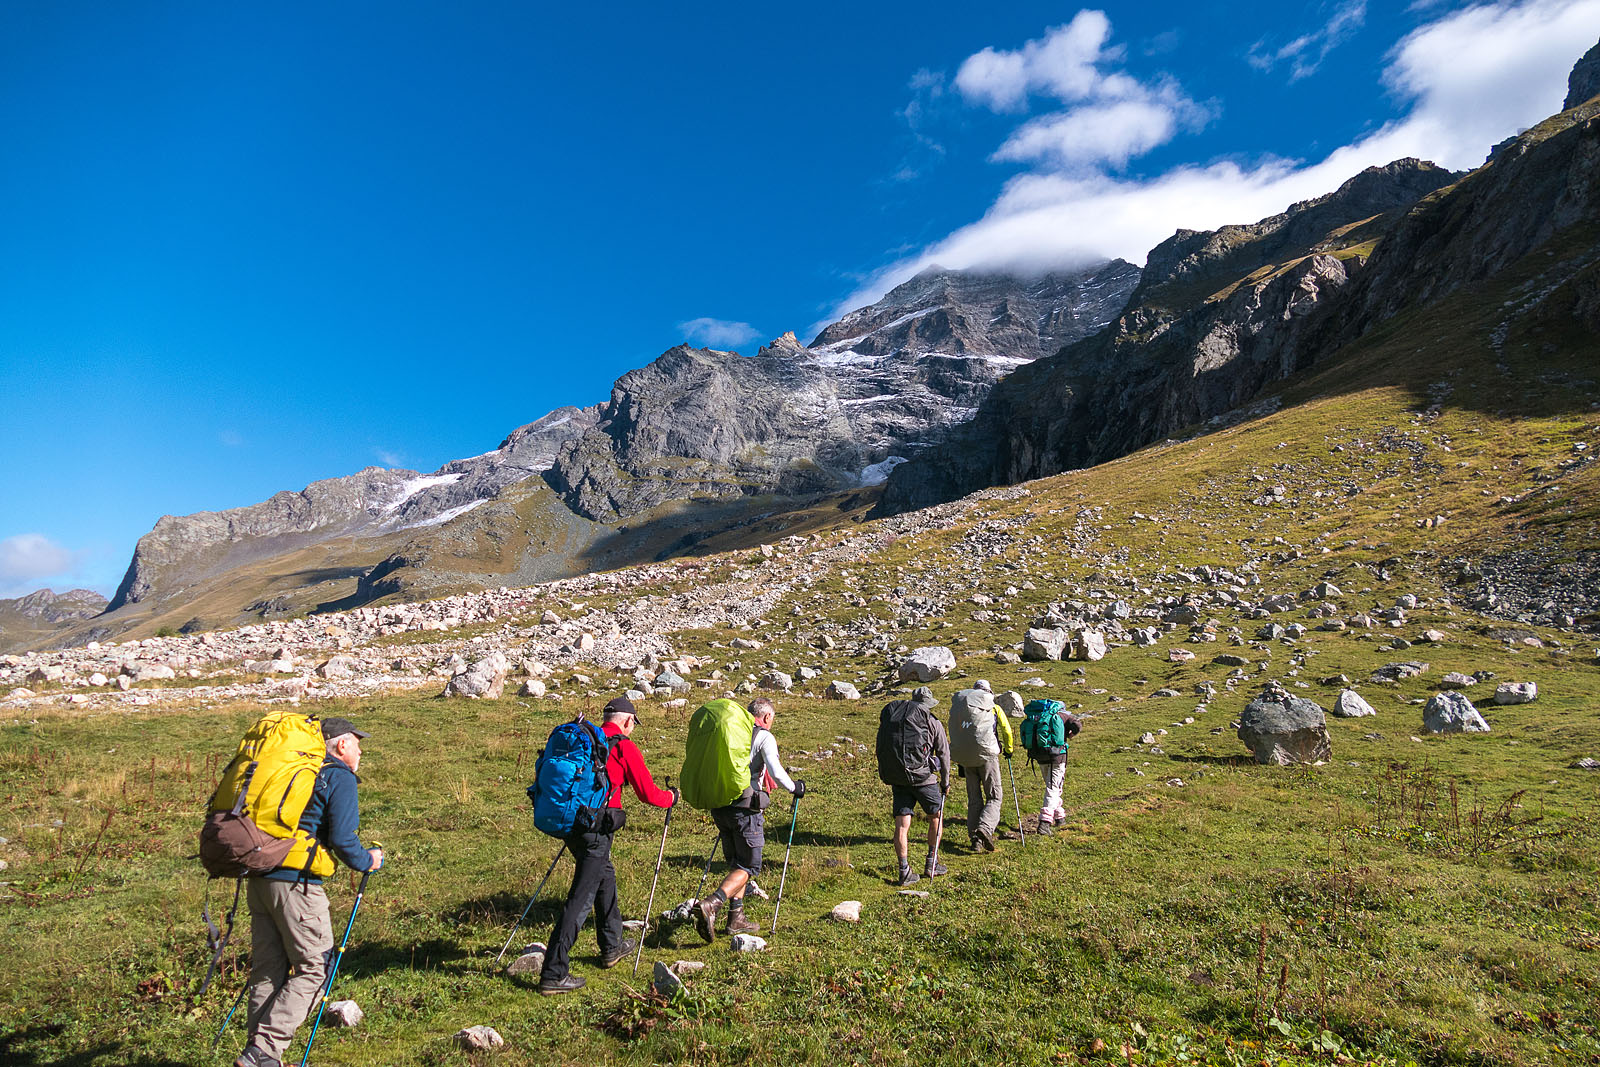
[200,712,384,1067]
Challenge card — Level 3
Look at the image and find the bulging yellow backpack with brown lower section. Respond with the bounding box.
[200,712,334,878]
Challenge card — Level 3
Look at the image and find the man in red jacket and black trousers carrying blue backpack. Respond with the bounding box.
[528,696,678,997]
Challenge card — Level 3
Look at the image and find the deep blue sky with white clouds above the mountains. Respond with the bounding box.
[0,0,1600,597]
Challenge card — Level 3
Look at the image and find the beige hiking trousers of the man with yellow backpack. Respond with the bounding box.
[245,878,333,1059]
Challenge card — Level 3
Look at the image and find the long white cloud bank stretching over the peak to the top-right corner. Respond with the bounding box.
[832,0,1600,326]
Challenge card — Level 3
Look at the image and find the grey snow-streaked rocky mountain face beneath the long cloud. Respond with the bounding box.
[546,261,1139,522]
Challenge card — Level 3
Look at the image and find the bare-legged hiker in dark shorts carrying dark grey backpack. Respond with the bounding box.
[877,686,950,886]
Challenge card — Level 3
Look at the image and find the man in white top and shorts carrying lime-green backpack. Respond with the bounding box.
[683,696,805,942]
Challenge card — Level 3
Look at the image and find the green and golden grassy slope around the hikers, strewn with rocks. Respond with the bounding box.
[9,244,1600,1064]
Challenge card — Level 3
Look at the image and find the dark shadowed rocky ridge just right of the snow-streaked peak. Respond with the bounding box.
[883,160,1456,510]
